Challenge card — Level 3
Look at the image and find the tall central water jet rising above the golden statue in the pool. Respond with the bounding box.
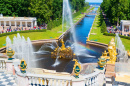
[62,0,95,62]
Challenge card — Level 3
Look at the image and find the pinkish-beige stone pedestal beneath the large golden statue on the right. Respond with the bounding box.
[105,64,116,77]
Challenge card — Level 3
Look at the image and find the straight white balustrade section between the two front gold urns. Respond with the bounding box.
[27,74,71,86]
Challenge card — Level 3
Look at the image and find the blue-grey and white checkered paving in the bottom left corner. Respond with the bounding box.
[0,72,17,86]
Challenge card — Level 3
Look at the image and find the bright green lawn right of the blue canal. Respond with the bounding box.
[89,11,130,50]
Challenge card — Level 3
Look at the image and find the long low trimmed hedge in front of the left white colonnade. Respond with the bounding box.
[0,29,46,37]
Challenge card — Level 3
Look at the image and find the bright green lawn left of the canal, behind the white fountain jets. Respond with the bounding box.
[0,8,93,48]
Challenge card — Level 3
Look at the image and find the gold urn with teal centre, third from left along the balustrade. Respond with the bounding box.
[73,59,81,78]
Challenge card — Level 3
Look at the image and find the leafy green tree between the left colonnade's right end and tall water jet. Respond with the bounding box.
[29,0,53,23]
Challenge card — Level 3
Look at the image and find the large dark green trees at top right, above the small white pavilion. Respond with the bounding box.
[101,0,130,25]
